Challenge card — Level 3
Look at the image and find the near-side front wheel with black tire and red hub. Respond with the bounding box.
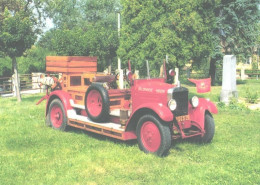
[136,114,171,156]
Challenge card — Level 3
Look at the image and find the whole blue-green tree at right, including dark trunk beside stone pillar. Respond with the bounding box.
[209,0,260,84]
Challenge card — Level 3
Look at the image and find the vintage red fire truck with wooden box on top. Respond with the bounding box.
[37,56,218,156]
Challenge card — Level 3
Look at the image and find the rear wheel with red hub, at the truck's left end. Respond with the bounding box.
[46,99,68,131]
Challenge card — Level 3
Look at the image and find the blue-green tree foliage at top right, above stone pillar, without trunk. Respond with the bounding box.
[217,0,260,56]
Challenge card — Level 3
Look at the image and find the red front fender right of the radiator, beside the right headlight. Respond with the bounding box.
[189,98,218,130]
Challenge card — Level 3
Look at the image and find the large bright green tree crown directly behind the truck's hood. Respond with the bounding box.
[118,0,213,76]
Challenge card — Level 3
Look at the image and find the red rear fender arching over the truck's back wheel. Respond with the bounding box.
[45,90,73,115]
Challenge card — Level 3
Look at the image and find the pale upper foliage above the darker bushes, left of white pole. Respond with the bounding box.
[45,0,118,30]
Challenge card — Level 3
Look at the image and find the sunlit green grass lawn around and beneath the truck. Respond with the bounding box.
[0,80,260,184]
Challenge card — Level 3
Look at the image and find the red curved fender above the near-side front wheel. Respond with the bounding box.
[134,103,173,122]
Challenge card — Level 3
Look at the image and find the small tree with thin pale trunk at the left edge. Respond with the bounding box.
[0,1,38,101]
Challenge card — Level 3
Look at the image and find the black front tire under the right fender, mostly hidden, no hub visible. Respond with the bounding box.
[196,113,215,143]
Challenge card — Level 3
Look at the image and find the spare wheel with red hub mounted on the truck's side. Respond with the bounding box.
[85,83,110,122]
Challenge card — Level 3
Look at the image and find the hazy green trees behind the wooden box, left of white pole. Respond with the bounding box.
[40,0,118,70]
